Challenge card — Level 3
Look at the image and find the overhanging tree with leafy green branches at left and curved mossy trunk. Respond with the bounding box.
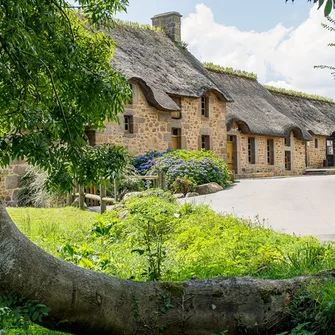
[0,0,332,335]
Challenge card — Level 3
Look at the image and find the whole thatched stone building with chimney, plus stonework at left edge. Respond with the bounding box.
[0,12,335,205]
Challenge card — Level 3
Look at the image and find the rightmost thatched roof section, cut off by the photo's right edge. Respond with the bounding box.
[272,92,335,136]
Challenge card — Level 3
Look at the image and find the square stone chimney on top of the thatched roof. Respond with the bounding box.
[151,12,182,41]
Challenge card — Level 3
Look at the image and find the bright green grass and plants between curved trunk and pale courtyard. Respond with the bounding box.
[9,198,335,281]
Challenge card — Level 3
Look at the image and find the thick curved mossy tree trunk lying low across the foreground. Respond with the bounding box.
[0,205,309,335]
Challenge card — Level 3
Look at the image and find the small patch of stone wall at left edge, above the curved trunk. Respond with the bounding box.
[0,161,27,206]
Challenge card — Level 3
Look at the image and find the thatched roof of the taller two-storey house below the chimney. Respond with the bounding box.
[111,23,232,110]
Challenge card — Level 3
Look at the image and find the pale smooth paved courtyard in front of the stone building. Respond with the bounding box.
[183,176,335,240]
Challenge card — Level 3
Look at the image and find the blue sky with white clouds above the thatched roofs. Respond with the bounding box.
[113,0,335,98]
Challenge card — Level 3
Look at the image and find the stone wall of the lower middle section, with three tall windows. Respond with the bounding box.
[237,134,306,178]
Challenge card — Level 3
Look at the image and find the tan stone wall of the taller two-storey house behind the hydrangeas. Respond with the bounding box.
[96,84,227,158]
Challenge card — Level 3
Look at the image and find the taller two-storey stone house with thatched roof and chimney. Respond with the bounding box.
[95,12,232,157]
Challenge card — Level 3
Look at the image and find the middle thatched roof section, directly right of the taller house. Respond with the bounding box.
[208,69,311,140]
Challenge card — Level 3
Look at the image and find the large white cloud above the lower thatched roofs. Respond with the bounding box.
[182,4,335,98]
